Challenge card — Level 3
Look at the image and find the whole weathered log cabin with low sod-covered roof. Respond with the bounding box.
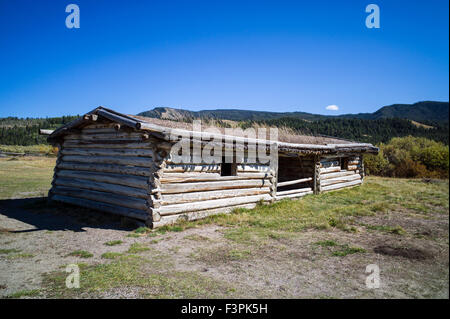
[44,107,378,228]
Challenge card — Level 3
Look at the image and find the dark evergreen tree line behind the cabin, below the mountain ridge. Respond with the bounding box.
[0,116,449,146]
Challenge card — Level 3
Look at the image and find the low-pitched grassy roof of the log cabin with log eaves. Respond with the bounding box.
[48,106,378,153]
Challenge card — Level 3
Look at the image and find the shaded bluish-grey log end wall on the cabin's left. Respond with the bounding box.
[49,123,158,221]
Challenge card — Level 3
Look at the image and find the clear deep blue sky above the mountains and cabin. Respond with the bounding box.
[0,0,449,117]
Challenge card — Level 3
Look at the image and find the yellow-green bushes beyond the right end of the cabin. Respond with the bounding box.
[364,136,449,178]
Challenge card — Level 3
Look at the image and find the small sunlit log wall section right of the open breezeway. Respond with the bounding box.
[316,155,364,192]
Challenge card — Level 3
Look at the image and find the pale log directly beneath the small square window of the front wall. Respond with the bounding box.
[159,173,270,183]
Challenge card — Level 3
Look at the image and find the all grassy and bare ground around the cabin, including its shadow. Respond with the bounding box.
[0,157,449,298]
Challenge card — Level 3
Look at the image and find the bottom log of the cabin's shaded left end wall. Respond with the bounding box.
[51,194,149,221]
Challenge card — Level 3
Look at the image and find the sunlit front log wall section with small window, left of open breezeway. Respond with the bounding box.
[151,161,275,227]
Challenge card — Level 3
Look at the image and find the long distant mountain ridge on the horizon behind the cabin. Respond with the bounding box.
[138,101,449,123]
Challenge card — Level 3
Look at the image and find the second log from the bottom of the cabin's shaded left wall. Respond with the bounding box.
[52,186,148,211]
